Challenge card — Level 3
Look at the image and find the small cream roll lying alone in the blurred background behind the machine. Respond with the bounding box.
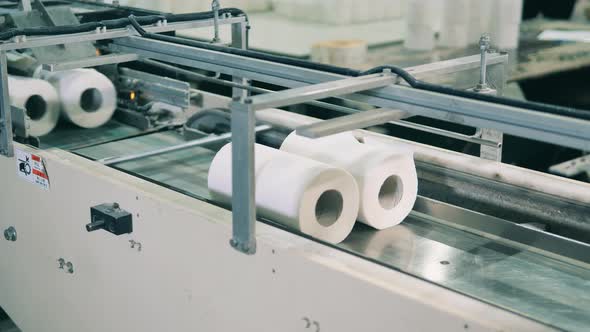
[311,40,367,68]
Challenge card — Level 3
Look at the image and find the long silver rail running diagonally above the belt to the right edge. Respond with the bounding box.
[115,37,590,150]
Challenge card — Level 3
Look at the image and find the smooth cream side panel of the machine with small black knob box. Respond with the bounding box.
[0,144,549,332]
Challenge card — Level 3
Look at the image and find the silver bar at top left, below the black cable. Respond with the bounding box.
[0,16,245,53]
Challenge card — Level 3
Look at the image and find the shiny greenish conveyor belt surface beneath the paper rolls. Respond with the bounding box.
[57,127,590,330]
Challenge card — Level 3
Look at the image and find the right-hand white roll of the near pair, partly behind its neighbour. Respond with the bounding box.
[281,132,418,229]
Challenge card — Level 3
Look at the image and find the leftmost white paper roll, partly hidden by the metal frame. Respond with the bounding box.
[8,75,60,136]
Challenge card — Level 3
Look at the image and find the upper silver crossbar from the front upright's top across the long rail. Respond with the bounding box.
[245,74,395,110]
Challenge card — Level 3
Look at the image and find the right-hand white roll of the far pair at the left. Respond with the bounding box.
[42,69,117,128]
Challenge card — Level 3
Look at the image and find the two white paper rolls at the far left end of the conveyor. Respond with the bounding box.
[8,69,117,136]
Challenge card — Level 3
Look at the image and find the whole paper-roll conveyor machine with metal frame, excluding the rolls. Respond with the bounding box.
[0,1,590,331]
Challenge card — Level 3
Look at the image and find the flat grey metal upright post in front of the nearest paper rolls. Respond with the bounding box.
[230,102,256,255]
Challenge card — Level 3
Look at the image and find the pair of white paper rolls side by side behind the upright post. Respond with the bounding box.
[208,132,418,243]
